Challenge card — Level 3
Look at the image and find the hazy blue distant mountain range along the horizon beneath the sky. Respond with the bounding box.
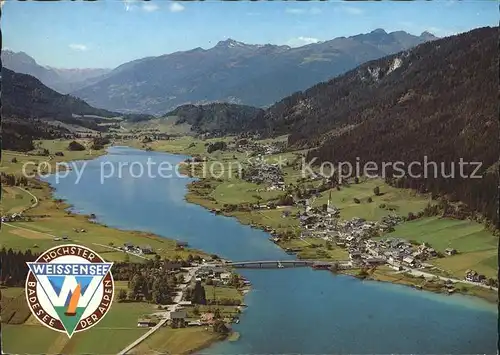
[2,29,437,115]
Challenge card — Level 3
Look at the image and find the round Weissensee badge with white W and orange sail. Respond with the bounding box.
[26,244,114,338]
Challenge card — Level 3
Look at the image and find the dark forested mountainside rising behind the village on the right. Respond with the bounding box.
[254,27,499,222]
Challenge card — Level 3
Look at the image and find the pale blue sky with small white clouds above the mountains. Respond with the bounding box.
[2,0,498,68]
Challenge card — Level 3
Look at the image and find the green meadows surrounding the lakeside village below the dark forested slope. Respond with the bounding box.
[131,138,498,302]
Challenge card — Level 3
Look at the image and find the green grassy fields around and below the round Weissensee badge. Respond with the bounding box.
[1,281,238,354]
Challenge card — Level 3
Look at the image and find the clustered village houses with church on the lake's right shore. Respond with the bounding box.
[229,155,497,292]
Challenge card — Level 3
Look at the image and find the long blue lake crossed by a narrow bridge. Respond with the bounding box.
[47,147,498,354]
